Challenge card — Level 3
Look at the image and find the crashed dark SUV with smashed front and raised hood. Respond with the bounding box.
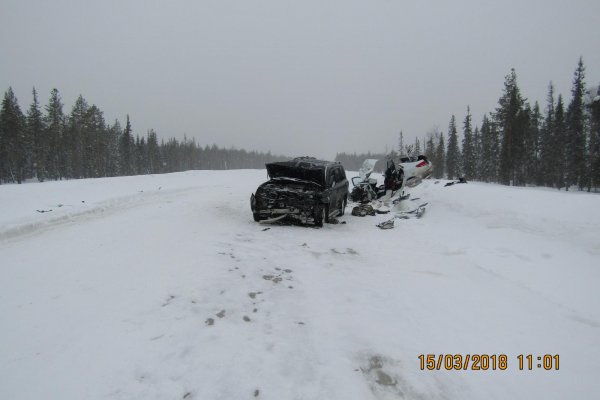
[250,157,348,226]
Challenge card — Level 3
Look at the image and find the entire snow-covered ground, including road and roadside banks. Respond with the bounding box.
[0,170,600,400]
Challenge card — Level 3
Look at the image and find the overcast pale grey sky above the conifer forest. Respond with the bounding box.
[0,0,600,159]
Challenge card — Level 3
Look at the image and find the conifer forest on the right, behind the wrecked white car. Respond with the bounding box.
[336,58,600,191]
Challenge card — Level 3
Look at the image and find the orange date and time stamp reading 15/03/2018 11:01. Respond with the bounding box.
[418,354,560,371]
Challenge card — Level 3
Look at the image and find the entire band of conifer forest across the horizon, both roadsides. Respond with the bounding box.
[0,58,600,191]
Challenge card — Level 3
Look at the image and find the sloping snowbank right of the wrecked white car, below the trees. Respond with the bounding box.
[421,181,600,316]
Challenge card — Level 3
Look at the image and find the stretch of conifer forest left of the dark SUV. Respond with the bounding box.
[0,87,286,184]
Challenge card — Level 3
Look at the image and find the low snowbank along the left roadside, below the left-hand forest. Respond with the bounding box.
[0,171,264,239]
